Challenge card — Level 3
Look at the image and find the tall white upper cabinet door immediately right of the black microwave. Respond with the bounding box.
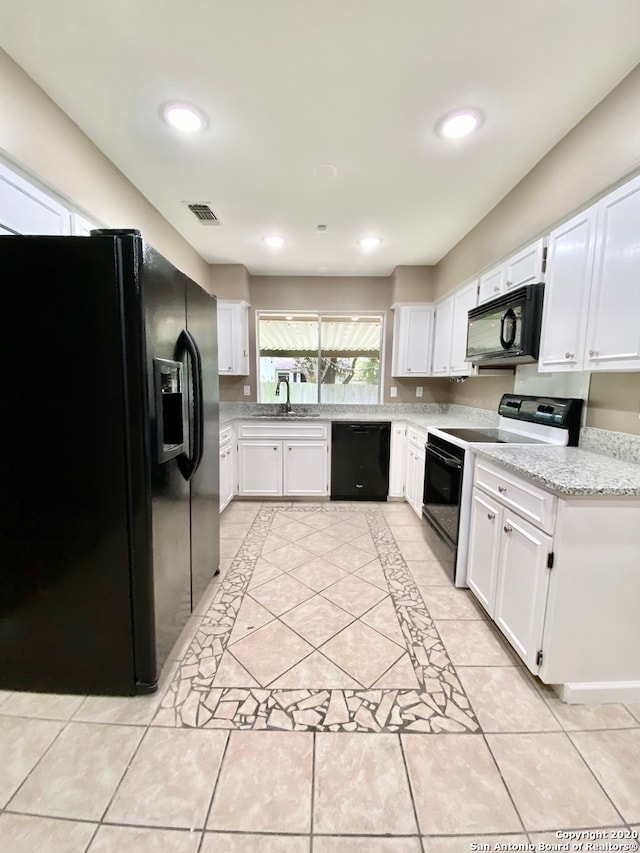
[538,205,597,373]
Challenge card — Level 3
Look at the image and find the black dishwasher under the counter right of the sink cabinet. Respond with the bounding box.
[331,421,391,501]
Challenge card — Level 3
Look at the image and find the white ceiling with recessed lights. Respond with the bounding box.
[0,0,640,275]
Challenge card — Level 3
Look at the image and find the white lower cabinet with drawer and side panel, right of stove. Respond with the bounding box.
[467,458,640,702]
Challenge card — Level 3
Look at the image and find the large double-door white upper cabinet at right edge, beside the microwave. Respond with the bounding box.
[538,171,640,372]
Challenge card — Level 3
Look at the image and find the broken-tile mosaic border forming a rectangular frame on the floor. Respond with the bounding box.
[152,503,479,733]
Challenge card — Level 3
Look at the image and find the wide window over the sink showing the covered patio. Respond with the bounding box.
[257,311,384,405]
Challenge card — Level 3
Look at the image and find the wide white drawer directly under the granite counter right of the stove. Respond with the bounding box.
[475,459,556,533]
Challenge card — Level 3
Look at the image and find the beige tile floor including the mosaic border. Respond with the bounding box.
[0,502,640,853]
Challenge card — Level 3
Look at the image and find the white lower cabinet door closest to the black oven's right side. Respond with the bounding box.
[467,489,502,616]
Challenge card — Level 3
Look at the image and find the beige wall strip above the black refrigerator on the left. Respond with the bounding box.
[0,50,209,289]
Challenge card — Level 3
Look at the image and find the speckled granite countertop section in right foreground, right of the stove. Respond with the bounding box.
[474,444,640,497]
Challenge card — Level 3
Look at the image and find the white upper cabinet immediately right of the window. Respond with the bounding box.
[391,303,433,376]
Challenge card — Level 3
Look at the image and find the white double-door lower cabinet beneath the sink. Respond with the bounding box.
[238,421,329,497]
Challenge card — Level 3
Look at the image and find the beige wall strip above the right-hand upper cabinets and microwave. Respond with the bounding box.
[435,65,640,296]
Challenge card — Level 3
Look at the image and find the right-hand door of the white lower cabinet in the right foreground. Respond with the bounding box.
[494,509,552,672]
